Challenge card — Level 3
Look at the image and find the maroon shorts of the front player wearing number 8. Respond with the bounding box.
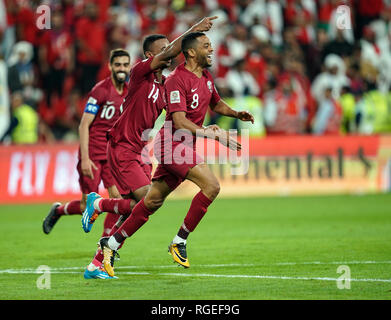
[152,144,204,190]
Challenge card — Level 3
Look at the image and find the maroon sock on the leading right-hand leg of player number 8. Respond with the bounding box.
[178,191,212,239]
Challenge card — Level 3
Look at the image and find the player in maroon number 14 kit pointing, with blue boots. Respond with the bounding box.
[82,17,217,278]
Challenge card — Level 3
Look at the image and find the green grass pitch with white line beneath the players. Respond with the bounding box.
[0,194,391,300]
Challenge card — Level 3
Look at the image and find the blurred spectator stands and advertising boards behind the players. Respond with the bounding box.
[0,0,391,203]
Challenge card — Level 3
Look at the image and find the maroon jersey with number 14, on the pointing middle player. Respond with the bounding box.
[109,57,167,154]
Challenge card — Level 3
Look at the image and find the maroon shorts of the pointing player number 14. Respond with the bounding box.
[107,142,152,195]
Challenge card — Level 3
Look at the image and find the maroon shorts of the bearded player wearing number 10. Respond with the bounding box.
[77,159,115,194]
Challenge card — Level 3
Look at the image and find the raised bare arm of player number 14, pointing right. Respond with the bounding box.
[151,16,218,70]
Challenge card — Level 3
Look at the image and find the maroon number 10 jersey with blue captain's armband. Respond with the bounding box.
[84,77,128,160]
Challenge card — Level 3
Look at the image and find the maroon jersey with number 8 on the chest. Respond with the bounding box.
[161,63,220,146]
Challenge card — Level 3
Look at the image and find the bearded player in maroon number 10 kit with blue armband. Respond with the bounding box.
[43,49,130,262]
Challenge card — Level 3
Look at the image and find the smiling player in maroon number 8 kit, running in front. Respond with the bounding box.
[96,32,254,276]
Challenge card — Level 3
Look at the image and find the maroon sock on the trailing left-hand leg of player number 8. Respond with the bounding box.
[113,198,154,243]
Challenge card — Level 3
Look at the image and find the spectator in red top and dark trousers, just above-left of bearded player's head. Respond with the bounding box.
[75,2,106,95]
